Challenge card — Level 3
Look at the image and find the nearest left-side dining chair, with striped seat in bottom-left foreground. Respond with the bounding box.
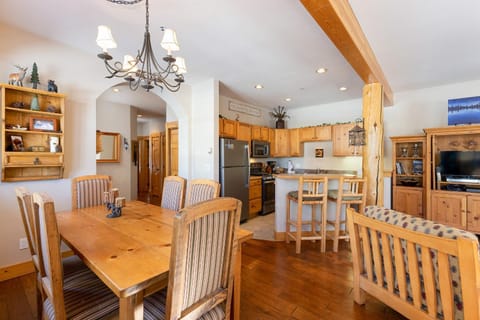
[33,193,119,320]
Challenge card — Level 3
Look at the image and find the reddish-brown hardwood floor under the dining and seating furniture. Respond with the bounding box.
[0,240,404,320]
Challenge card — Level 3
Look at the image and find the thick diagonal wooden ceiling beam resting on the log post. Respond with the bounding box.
[300,0,393,106]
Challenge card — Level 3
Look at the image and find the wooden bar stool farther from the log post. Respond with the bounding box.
[285,176,328,253]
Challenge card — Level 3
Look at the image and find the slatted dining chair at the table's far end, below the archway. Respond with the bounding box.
[72,175,112,209]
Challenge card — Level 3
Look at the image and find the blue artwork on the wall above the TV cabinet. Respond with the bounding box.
[448,97,480,126]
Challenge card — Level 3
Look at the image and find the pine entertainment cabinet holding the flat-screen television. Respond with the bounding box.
[424,125,480,233]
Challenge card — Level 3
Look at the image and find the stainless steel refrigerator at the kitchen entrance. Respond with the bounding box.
[220,138,250,222]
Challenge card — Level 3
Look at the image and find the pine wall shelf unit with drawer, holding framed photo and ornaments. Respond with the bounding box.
[0,84,66,181]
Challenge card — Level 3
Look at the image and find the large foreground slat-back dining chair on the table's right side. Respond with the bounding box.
[144,198,242,320]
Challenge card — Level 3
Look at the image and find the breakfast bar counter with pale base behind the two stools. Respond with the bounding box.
[274,170,356,240]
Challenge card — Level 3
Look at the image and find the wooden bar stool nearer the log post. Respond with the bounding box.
[325,177,367,252]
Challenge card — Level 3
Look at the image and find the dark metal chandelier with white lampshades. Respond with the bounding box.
[97,0,187,92]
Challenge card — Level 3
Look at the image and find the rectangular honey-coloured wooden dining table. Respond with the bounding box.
[57,201,252,319]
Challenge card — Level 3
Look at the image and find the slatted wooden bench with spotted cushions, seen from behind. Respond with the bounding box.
[347,206,480,319]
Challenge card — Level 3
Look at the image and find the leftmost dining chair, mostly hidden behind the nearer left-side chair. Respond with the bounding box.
[15,187,88,319]
